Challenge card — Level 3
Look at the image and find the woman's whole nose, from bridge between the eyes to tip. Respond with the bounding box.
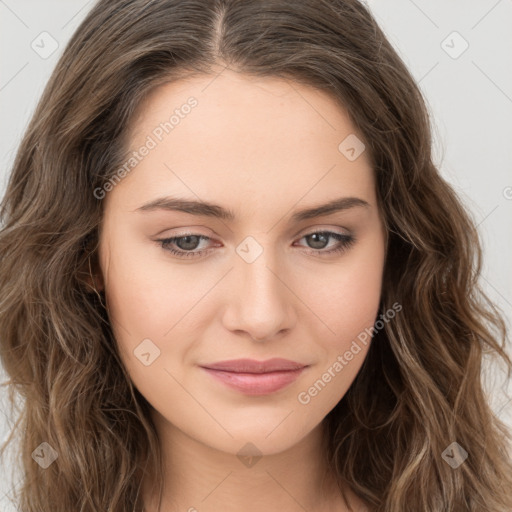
[225,236,293,339]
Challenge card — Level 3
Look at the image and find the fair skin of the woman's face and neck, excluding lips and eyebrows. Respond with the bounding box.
[96,70,386,512]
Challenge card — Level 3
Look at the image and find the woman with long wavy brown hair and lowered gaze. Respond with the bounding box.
[0,0,512,512]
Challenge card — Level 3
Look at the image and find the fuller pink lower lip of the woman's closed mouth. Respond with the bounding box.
[202,367,306,395]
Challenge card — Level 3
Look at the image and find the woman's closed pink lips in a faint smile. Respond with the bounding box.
[201,359,308,395]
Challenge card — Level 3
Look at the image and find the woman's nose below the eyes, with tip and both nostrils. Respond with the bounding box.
[223,246,297,342]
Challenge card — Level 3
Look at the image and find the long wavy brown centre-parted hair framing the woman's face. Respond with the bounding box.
[0,0,512,512]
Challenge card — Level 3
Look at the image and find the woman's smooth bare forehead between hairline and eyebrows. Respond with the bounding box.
[110,70,374,218]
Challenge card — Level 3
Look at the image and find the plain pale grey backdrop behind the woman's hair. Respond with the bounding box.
[0,0,512,511]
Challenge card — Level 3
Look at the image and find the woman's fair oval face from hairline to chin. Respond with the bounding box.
[99,70,386,454]
